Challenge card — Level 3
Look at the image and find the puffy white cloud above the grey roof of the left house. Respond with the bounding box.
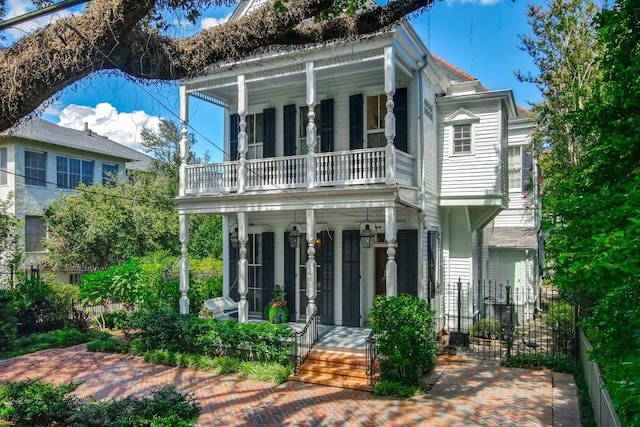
[58,102,160,150]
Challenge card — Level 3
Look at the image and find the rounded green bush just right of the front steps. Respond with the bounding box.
[369,294,437,384]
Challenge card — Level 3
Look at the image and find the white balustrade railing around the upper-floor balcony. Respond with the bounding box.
[185,147,415,195]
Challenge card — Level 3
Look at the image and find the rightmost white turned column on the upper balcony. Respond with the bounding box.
[384,46,396,185]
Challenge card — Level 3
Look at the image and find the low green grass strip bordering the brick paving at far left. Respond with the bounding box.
[0,328,108,359]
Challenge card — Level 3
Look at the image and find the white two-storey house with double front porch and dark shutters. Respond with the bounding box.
[171,0,536,327]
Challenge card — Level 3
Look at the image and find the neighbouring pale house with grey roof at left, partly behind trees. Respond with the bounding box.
[0,117,151,265]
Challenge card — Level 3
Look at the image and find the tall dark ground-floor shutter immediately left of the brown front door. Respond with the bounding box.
[342,230,360,327]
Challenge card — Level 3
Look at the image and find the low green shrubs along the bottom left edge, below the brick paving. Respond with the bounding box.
[0,379,201,427]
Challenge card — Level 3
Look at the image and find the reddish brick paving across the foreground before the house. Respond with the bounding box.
[0,345,572,427]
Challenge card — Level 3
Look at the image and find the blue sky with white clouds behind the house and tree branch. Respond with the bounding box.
[5,0,540,160]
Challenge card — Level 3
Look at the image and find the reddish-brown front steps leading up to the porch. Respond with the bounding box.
[289,350,378,391]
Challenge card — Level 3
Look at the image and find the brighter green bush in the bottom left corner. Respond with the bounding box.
[0,379,80,425]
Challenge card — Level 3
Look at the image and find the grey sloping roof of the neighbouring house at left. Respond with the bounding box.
[0,117,151,169]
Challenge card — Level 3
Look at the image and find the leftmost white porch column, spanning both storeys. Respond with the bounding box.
[178,86,189,314]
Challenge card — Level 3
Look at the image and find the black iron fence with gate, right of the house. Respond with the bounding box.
[438,280,578,359]
